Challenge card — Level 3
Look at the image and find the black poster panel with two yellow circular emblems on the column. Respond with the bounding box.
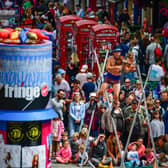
[7,122,41,146]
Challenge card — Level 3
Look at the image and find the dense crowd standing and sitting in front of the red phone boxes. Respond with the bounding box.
[52,31,168,167]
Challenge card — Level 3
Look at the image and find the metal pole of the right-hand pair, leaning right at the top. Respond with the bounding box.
[121,67,151,164]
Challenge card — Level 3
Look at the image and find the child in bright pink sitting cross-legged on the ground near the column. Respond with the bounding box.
[56,140,72,163]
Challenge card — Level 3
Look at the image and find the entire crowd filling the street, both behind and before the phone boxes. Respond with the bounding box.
[7,0,168,167]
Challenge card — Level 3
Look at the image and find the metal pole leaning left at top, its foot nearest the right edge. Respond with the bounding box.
[137,65,159,167]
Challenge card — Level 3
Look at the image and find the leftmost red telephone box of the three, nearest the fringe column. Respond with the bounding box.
[56,15,82,69]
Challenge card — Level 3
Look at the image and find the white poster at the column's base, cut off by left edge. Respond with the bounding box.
[0,145,21,168]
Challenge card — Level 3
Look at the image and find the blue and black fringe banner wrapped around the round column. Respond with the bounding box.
[0,41,52,111]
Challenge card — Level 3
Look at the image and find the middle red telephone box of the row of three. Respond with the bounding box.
[74,20,98,67]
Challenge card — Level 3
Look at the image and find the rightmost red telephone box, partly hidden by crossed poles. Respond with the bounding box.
[89,24,119,76]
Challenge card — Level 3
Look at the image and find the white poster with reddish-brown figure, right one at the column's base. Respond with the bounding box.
[22,145,46,168]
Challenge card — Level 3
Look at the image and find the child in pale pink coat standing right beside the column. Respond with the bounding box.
[51,117,64,157]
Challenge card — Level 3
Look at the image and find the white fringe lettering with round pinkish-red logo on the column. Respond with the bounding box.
[4,84,45,100]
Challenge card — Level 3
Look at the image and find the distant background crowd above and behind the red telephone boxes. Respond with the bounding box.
[14,0,142,31]
